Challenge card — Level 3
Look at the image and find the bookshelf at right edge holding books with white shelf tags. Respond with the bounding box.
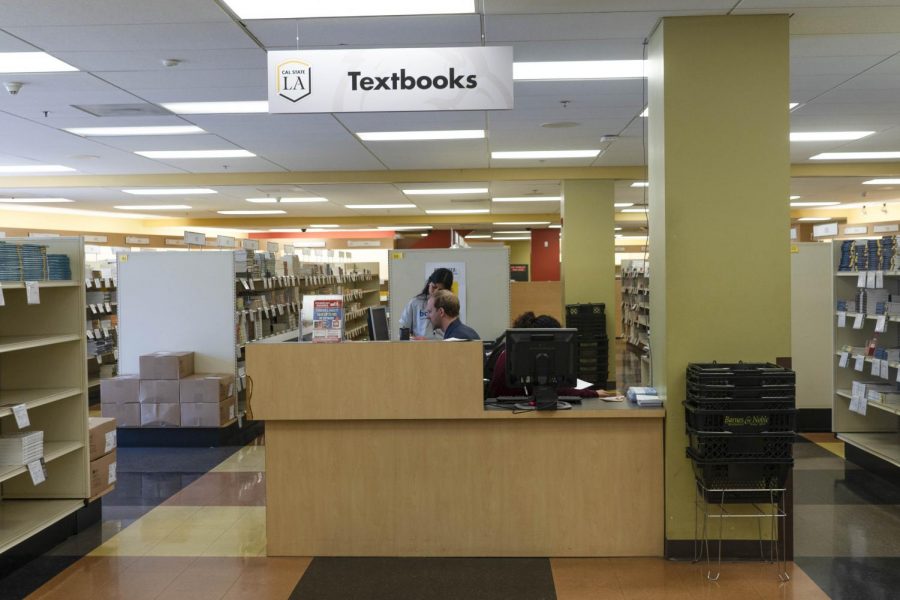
[832,240,900,467]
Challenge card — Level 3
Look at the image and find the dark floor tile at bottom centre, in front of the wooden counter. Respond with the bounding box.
[291,558,556,600]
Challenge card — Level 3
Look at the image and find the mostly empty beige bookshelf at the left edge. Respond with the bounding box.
[0,237,90,552]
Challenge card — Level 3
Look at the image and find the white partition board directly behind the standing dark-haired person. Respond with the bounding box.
[388,246,509,340]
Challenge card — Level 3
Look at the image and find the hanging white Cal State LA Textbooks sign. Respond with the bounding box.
[268,46,513,113]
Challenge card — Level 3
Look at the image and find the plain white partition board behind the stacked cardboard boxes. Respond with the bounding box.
[118,252,235,374]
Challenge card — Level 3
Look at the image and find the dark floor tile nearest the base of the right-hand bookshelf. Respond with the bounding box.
[794,469,900,504]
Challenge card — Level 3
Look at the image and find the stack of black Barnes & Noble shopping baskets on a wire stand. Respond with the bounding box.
[684,363,797,502]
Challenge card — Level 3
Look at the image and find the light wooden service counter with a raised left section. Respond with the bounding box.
[247,342,664,557]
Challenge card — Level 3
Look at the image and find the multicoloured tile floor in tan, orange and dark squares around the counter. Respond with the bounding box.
[0,344,900,600]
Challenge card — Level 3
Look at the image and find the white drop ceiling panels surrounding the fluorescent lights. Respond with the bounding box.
[0,0,900,228]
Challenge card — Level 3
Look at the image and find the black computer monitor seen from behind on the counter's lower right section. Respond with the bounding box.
[506,328,578,410]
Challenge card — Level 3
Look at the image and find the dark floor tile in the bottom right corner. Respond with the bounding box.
[795,557,900,600]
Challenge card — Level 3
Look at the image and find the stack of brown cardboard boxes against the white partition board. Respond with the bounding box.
[100,352,236,427]
